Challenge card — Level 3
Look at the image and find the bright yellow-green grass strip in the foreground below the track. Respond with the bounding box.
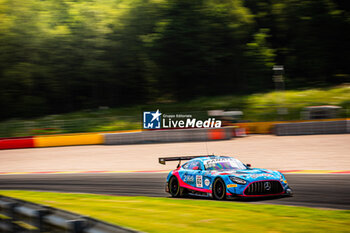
[0,191,350,233]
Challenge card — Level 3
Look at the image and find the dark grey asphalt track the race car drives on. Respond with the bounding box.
[0,173,350,210]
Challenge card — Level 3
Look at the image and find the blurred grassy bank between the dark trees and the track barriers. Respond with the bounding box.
[0,85,350,137]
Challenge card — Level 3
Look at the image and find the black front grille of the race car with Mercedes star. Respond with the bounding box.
[244,180,283,196]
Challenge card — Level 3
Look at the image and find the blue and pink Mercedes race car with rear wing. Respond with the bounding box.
[159,155,292,200]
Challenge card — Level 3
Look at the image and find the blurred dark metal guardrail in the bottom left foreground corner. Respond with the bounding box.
[0,195,137,233]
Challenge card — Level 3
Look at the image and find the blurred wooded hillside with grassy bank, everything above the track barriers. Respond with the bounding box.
[0,0,350,137]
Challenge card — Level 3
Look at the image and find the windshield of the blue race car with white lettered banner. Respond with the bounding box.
[204,158,246,171]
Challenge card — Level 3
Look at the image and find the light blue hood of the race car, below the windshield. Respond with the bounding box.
[218,168,281,181]
